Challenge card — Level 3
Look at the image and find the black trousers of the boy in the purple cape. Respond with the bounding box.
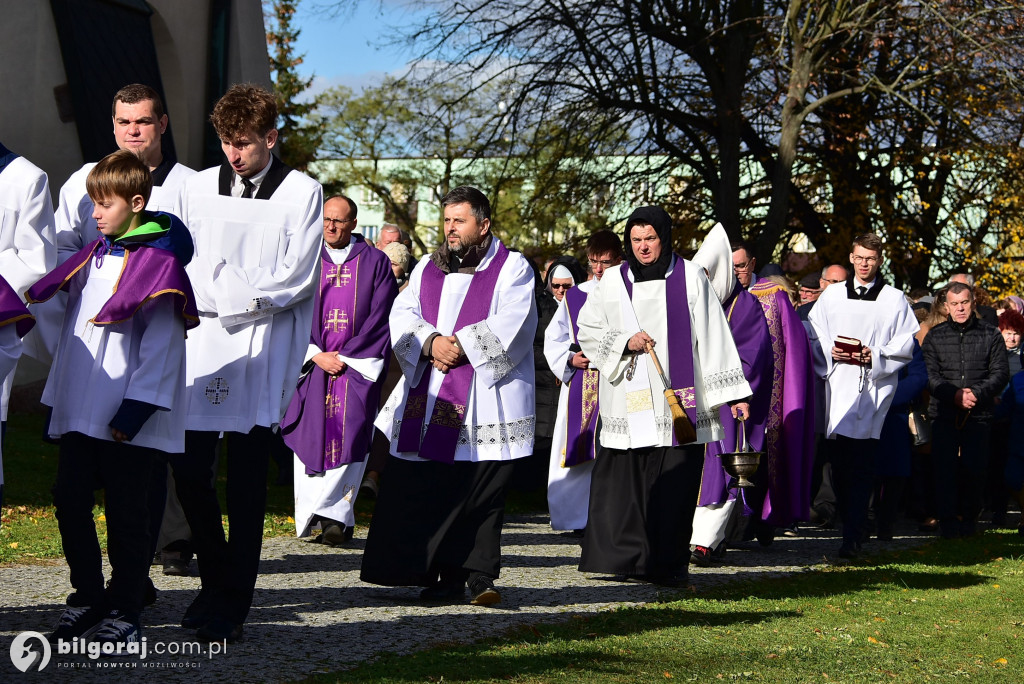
[53,432,157,614]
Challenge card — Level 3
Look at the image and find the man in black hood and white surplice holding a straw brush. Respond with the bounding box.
[579,207,751,586]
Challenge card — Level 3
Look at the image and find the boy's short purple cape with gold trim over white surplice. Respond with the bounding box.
[25,239,199,330]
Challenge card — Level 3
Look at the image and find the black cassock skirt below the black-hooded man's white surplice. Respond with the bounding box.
[580,444,705,579]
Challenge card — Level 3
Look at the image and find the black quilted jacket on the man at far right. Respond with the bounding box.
[923,315,1010,422]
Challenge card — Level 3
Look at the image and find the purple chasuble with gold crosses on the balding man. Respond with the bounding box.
[281,240,398,475]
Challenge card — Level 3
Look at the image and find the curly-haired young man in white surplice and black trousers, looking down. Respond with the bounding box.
[171,84,324,641]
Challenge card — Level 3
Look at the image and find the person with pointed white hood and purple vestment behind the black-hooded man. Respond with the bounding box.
[690,223,774,565]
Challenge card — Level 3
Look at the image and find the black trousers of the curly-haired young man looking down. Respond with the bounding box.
[169,426,273,625]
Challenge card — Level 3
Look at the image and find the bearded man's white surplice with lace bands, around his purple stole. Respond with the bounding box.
[374,238,537,462]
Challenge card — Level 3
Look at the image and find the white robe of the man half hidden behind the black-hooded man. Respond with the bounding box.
[544,281,597,529]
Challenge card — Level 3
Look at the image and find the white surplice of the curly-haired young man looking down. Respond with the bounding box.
[173,167,324,433]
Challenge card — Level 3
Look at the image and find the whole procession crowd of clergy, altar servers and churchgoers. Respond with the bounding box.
[0,84,1024,652]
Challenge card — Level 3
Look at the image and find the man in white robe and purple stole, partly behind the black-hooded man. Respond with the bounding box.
[544,230,623,533]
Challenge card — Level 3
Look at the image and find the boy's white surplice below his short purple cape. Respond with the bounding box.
[41,254,185,450]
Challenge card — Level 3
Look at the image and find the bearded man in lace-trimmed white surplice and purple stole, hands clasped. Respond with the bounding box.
[361,186,537,605]
